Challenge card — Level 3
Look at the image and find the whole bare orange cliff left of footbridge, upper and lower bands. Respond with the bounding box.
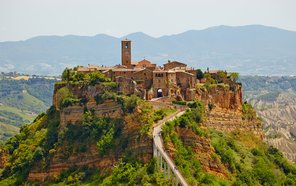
[28,83,153,182]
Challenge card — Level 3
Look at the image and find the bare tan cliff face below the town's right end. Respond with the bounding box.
[195,84,263,139]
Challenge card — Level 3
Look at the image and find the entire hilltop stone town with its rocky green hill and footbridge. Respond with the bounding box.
[0,40,294,186]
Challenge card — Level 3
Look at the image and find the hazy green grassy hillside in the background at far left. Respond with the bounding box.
[0,79,54,141]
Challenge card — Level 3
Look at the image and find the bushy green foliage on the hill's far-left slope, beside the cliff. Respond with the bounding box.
[0,108,59,185]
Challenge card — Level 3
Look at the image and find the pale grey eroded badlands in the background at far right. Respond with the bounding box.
[247,91,296,162]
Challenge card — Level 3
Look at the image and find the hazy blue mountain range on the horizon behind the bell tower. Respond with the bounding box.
[0,25,296,75]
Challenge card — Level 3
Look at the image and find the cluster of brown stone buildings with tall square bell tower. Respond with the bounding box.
[77,39,196,100]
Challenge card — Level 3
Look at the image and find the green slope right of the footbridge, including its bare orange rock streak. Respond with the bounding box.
[163,104,296,185]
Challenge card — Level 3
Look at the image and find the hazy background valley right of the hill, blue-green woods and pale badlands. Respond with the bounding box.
[241,77,296,162]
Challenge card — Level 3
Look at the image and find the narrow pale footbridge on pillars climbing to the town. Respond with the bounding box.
[153,110,188,186]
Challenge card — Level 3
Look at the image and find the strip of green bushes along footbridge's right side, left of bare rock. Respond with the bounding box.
[162,102,222,185]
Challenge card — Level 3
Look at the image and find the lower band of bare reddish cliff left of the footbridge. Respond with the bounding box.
[28,109,153,182]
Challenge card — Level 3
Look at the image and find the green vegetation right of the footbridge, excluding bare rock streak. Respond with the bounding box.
[163,102,296,185]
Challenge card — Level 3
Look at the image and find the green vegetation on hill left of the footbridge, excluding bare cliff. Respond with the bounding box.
[0,71,174,185]
